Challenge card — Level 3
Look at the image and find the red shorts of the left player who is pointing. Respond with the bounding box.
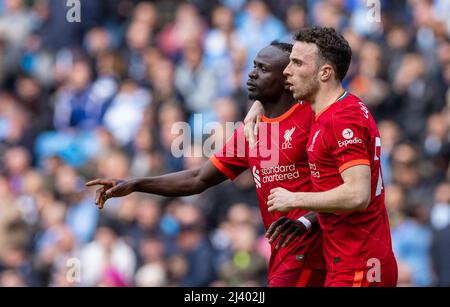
[269,269,327,287]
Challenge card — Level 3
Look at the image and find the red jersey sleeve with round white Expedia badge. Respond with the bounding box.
[325,108,370,173]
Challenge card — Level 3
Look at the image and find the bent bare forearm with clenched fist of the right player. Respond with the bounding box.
[267,165,371,212]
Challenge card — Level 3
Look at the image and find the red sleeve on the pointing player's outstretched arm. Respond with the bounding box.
[210,125,249,180]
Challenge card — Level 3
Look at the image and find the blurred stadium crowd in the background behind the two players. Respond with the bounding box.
[0,0,450,286]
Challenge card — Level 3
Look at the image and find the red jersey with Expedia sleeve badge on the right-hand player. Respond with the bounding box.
[307,92,394,271]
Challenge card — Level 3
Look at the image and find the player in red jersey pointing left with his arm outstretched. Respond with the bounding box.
[87,43,326,287]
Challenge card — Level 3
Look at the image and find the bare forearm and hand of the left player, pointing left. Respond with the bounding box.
[86,160,228,209]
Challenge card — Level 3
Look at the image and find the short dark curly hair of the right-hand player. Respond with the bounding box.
[294,27,352,81]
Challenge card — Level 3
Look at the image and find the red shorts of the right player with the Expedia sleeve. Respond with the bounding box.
[325,261,398,287]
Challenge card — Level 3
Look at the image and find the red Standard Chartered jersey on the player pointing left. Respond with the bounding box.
[211,103,325,278]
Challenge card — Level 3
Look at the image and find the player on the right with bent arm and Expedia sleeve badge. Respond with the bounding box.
[268,28,397,286]
